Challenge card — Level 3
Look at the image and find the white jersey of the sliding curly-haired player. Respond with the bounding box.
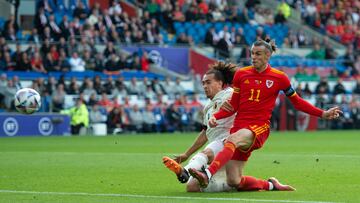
[203,87,235,143]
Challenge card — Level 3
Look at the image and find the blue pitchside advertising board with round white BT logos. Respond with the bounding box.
[0,113,70,137]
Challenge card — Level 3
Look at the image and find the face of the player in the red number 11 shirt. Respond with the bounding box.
[251,46,270,70]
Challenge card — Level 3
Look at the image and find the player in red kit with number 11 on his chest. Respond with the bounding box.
[189,39,342,191]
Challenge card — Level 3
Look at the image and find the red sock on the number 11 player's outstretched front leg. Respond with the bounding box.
[208,141,236,175]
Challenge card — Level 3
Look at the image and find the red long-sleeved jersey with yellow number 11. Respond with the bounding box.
[214,64,323,126]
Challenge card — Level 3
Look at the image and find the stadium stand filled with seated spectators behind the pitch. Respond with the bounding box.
[0,0,360,133]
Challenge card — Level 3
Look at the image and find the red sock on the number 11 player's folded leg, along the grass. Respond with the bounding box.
[238,176,269,191]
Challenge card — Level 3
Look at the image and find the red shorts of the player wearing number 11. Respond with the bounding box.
[230,123,270,161]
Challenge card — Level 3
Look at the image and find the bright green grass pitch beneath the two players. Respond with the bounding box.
[0,131,360,203]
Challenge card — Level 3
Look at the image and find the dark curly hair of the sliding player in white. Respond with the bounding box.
[205,61,237,85]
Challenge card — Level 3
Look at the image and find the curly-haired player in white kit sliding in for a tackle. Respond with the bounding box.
[163,62,237,192]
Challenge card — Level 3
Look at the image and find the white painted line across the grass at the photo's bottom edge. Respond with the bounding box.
[0,190,335,203]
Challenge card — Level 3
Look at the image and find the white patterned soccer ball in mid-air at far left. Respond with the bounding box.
[15,88,41,114]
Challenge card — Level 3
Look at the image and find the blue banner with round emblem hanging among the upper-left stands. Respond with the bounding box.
[121,46,189,74]
